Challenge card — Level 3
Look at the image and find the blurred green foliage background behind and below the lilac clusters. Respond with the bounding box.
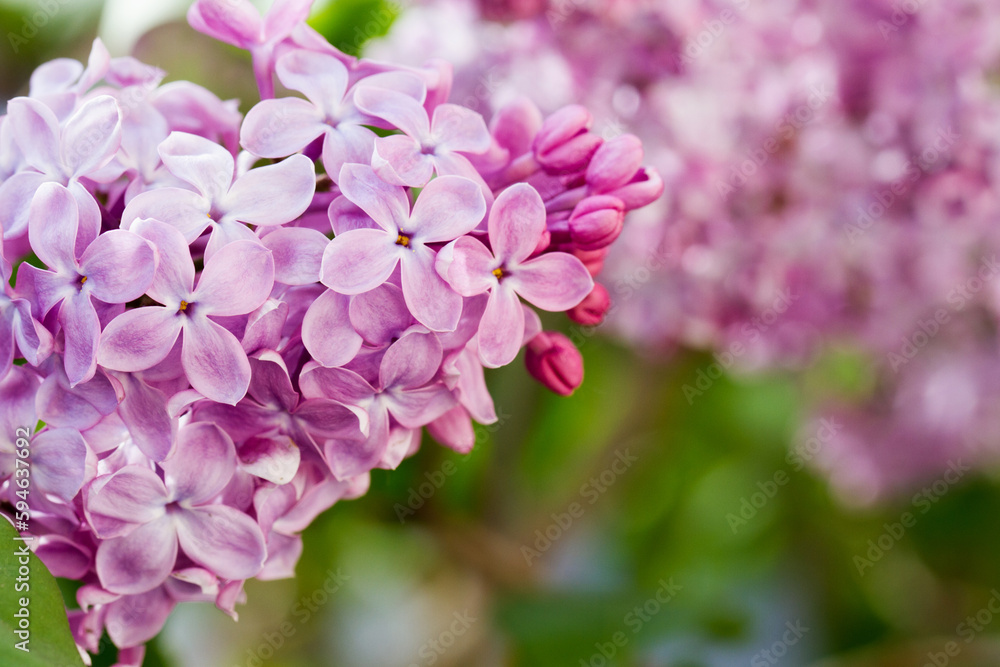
[0,0,1000,667]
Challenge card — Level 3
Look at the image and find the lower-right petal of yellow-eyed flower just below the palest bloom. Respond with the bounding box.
[181,317,250,405]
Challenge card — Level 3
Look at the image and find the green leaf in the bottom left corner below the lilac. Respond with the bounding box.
[0,519,83,667]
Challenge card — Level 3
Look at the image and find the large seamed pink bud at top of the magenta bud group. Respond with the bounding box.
[533,105,604,174]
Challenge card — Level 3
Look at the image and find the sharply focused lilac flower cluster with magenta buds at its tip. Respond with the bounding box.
[0,0,662,665]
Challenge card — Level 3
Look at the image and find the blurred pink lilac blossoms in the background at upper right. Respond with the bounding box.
[372,0,1000,502]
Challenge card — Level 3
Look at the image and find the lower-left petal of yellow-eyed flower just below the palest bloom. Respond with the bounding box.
[97,306,182,373]
